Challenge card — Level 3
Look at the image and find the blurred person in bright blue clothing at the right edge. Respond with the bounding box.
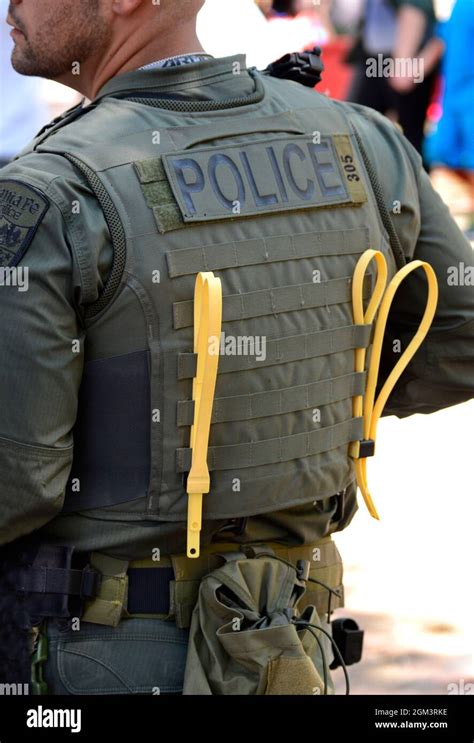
[426,0,474,240]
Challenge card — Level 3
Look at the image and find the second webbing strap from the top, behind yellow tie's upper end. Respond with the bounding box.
[173,276,358,330]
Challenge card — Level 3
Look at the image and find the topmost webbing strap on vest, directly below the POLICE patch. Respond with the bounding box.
[166,228,369,279]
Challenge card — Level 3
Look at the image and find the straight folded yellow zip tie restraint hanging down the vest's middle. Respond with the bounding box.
[187,271,222,558]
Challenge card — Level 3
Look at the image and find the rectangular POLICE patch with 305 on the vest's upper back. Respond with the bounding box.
[163,135,367,223]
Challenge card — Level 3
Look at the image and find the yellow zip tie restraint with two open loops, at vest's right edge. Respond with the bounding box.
[349,250,438,519]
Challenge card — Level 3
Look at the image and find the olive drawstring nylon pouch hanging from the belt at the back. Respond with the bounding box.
[183,553,334,695]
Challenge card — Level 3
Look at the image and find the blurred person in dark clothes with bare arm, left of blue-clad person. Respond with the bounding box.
[348,0,443,163]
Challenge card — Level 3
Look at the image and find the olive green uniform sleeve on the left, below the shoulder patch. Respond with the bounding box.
[0,155,112,544]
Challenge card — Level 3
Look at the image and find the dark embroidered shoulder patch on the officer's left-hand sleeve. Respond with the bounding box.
[0,178,50,267]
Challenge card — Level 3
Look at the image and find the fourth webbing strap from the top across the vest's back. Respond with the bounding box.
[177,372,366,426]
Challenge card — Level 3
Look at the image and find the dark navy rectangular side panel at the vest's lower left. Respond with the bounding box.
[63,351,151,512]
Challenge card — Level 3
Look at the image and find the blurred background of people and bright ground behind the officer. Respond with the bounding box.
[0,0,474,694]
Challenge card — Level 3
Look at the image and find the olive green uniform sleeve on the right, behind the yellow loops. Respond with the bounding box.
[340,105,474,417]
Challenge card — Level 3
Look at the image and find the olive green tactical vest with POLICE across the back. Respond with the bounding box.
[32,68,396,521]
